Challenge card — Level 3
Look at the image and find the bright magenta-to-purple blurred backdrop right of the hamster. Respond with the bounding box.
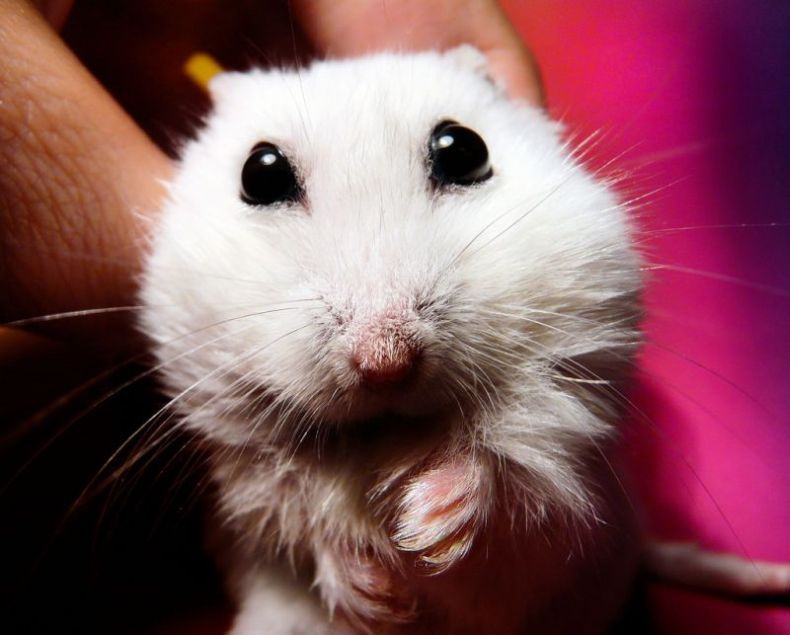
[504,0,790,634]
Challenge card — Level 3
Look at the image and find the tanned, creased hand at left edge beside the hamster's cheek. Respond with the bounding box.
[0,0,170,346]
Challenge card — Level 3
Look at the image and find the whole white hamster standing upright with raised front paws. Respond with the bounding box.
[140,47,788,635]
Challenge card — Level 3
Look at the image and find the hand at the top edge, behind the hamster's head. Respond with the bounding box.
[294,0,543,104]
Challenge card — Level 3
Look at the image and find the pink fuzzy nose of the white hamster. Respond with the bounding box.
[351,332,419,384]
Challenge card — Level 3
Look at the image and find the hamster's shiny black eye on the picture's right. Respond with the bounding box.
[428,121,494,185]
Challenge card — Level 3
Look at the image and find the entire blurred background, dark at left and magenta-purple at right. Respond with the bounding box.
[0,0,790,635]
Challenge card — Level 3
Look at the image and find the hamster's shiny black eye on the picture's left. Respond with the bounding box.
[241,143,302,205]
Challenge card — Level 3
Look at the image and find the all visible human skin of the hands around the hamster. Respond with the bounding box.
[0,0,542,348]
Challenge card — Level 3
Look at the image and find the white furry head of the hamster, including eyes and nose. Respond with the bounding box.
[142,48,639,452]
